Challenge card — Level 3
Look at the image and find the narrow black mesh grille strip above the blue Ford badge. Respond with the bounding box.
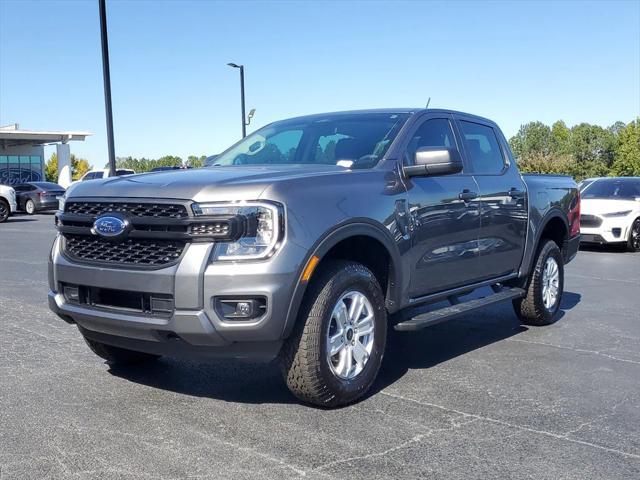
[64,202,189,218]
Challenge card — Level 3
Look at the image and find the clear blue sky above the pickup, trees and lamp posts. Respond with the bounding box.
[0,0,640,166]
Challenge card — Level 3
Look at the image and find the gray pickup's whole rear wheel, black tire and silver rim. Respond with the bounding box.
[513,240,564,326]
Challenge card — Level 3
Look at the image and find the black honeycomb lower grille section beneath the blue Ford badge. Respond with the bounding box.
[64,234,186,267]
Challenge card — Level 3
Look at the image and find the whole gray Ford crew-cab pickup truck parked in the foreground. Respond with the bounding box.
[49,109,580,407]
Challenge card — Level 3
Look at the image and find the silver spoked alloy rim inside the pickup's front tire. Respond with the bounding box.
[327,291,375,380]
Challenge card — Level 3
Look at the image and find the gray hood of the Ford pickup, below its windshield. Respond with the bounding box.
[67,165,349,202]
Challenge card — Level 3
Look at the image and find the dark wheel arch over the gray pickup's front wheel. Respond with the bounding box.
[282,219,403,338]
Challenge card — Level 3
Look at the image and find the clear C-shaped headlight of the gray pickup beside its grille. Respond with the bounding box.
[191,202,284,260]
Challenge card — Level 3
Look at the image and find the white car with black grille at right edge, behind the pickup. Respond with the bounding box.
[580,177,640,252]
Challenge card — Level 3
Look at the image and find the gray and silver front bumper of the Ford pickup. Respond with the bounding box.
[49,234,304,360]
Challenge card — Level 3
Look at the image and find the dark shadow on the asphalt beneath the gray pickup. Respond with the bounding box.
[109,292,581,404]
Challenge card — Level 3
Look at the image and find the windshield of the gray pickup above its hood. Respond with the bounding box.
[211,113,409,168]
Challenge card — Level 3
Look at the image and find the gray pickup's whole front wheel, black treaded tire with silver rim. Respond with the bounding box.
[280,261,387,407]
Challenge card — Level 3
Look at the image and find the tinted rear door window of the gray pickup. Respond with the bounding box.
[460,120,504,174]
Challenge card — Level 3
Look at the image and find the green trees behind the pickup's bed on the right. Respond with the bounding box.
[509,118,640,181]
